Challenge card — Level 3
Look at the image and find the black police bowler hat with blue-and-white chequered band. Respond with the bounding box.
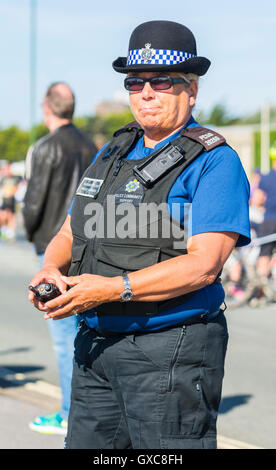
[112,21,211,75]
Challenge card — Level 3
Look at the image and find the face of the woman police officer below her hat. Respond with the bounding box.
[129,72,198,138]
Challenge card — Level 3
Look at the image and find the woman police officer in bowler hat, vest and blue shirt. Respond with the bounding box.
[30,21,250,449]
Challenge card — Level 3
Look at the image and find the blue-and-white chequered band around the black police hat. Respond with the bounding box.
[127,48,195,65]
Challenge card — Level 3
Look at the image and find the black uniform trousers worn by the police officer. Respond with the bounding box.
[65,312,228,449]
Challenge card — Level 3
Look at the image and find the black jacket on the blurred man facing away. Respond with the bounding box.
[23,124,97,254]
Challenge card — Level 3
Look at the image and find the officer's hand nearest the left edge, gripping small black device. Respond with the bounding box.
[28,265,67,311]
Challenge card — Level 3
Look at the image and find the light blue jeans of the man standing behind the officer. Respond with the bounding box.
[38,253,79,420]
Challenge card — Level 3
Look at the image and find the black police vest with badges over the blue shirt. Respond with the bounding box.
[68,122,225,315]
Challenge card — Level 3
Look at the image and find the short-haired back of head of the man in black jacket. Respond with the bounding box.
[45,82,75,119]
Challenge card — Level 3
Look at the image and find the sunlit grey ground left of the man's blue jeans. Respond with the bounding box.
[0,232,64,449]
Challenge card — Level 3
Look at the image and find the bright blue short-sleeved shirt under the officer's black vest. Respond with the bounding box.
[69,117,250,332]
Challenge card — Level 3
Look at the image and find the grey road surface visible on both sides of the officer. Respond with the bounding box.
[0,240,276,449]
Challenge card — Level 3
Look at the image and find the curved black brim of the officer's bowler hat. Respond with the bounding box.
[112,57,211,76]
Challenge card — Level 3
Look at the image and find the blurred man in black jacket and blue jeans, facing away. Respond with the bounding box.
[23,82,97,434]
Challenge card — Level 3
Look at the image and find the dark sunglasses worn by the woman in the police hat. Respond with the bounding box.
[124,76,190,91]
